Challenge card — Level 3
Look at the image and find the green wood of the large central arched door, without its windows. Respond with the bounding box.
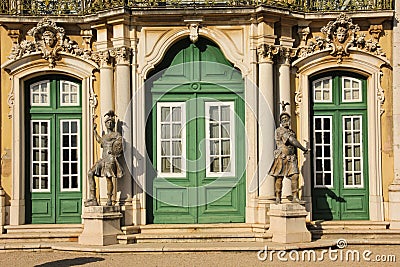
[147,38,246,223]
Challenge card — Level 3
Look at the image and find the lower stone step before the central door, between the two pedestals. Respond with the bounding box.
[117,232,272,244]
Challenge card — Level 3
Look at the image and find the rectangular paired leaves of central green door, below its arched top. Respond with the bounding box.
[153,94,245,223]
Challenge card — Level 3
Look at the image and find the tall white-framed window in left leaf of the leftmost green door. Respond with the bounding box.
[30,120,52,193]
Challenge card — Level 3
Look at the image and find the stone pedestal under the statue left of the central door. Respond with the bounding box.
[78,206,122,246]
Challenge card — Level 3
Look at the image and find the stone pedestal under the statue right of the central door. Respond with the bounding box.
[268,203,311,243]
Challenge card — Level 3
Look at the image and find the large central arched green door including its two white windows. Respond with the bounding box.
[147,38,245,223]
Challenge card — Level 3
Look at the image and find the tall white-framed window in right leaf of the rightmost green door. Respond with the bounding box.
[342,115,364,188]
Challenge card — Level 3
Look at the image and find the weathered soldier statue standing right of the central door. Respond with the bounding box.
[268,101,309,204]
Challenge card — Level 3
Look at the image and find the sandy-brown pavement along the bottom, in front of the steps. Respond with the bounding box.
[0,245,400,267]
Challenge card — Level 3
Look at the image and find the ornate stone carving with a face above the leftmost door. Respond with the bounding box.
[8,17,91,68]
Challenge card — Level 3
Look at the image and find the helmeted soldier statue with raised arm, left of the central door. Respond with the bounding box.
[85,110,124,206]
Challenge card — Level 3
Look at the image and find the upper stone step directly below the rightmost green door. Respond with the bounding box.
[307,221,390,230]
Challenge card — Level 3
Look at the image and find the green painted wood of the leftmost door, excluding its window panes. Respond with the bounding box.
[25,75,82,224]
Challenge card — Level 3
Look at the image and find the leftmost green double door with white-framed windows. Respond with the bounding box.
[25,76,82,224]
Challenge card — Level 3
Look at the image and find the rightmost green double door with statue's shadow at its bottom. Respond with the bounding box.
[311,72,369,220]
